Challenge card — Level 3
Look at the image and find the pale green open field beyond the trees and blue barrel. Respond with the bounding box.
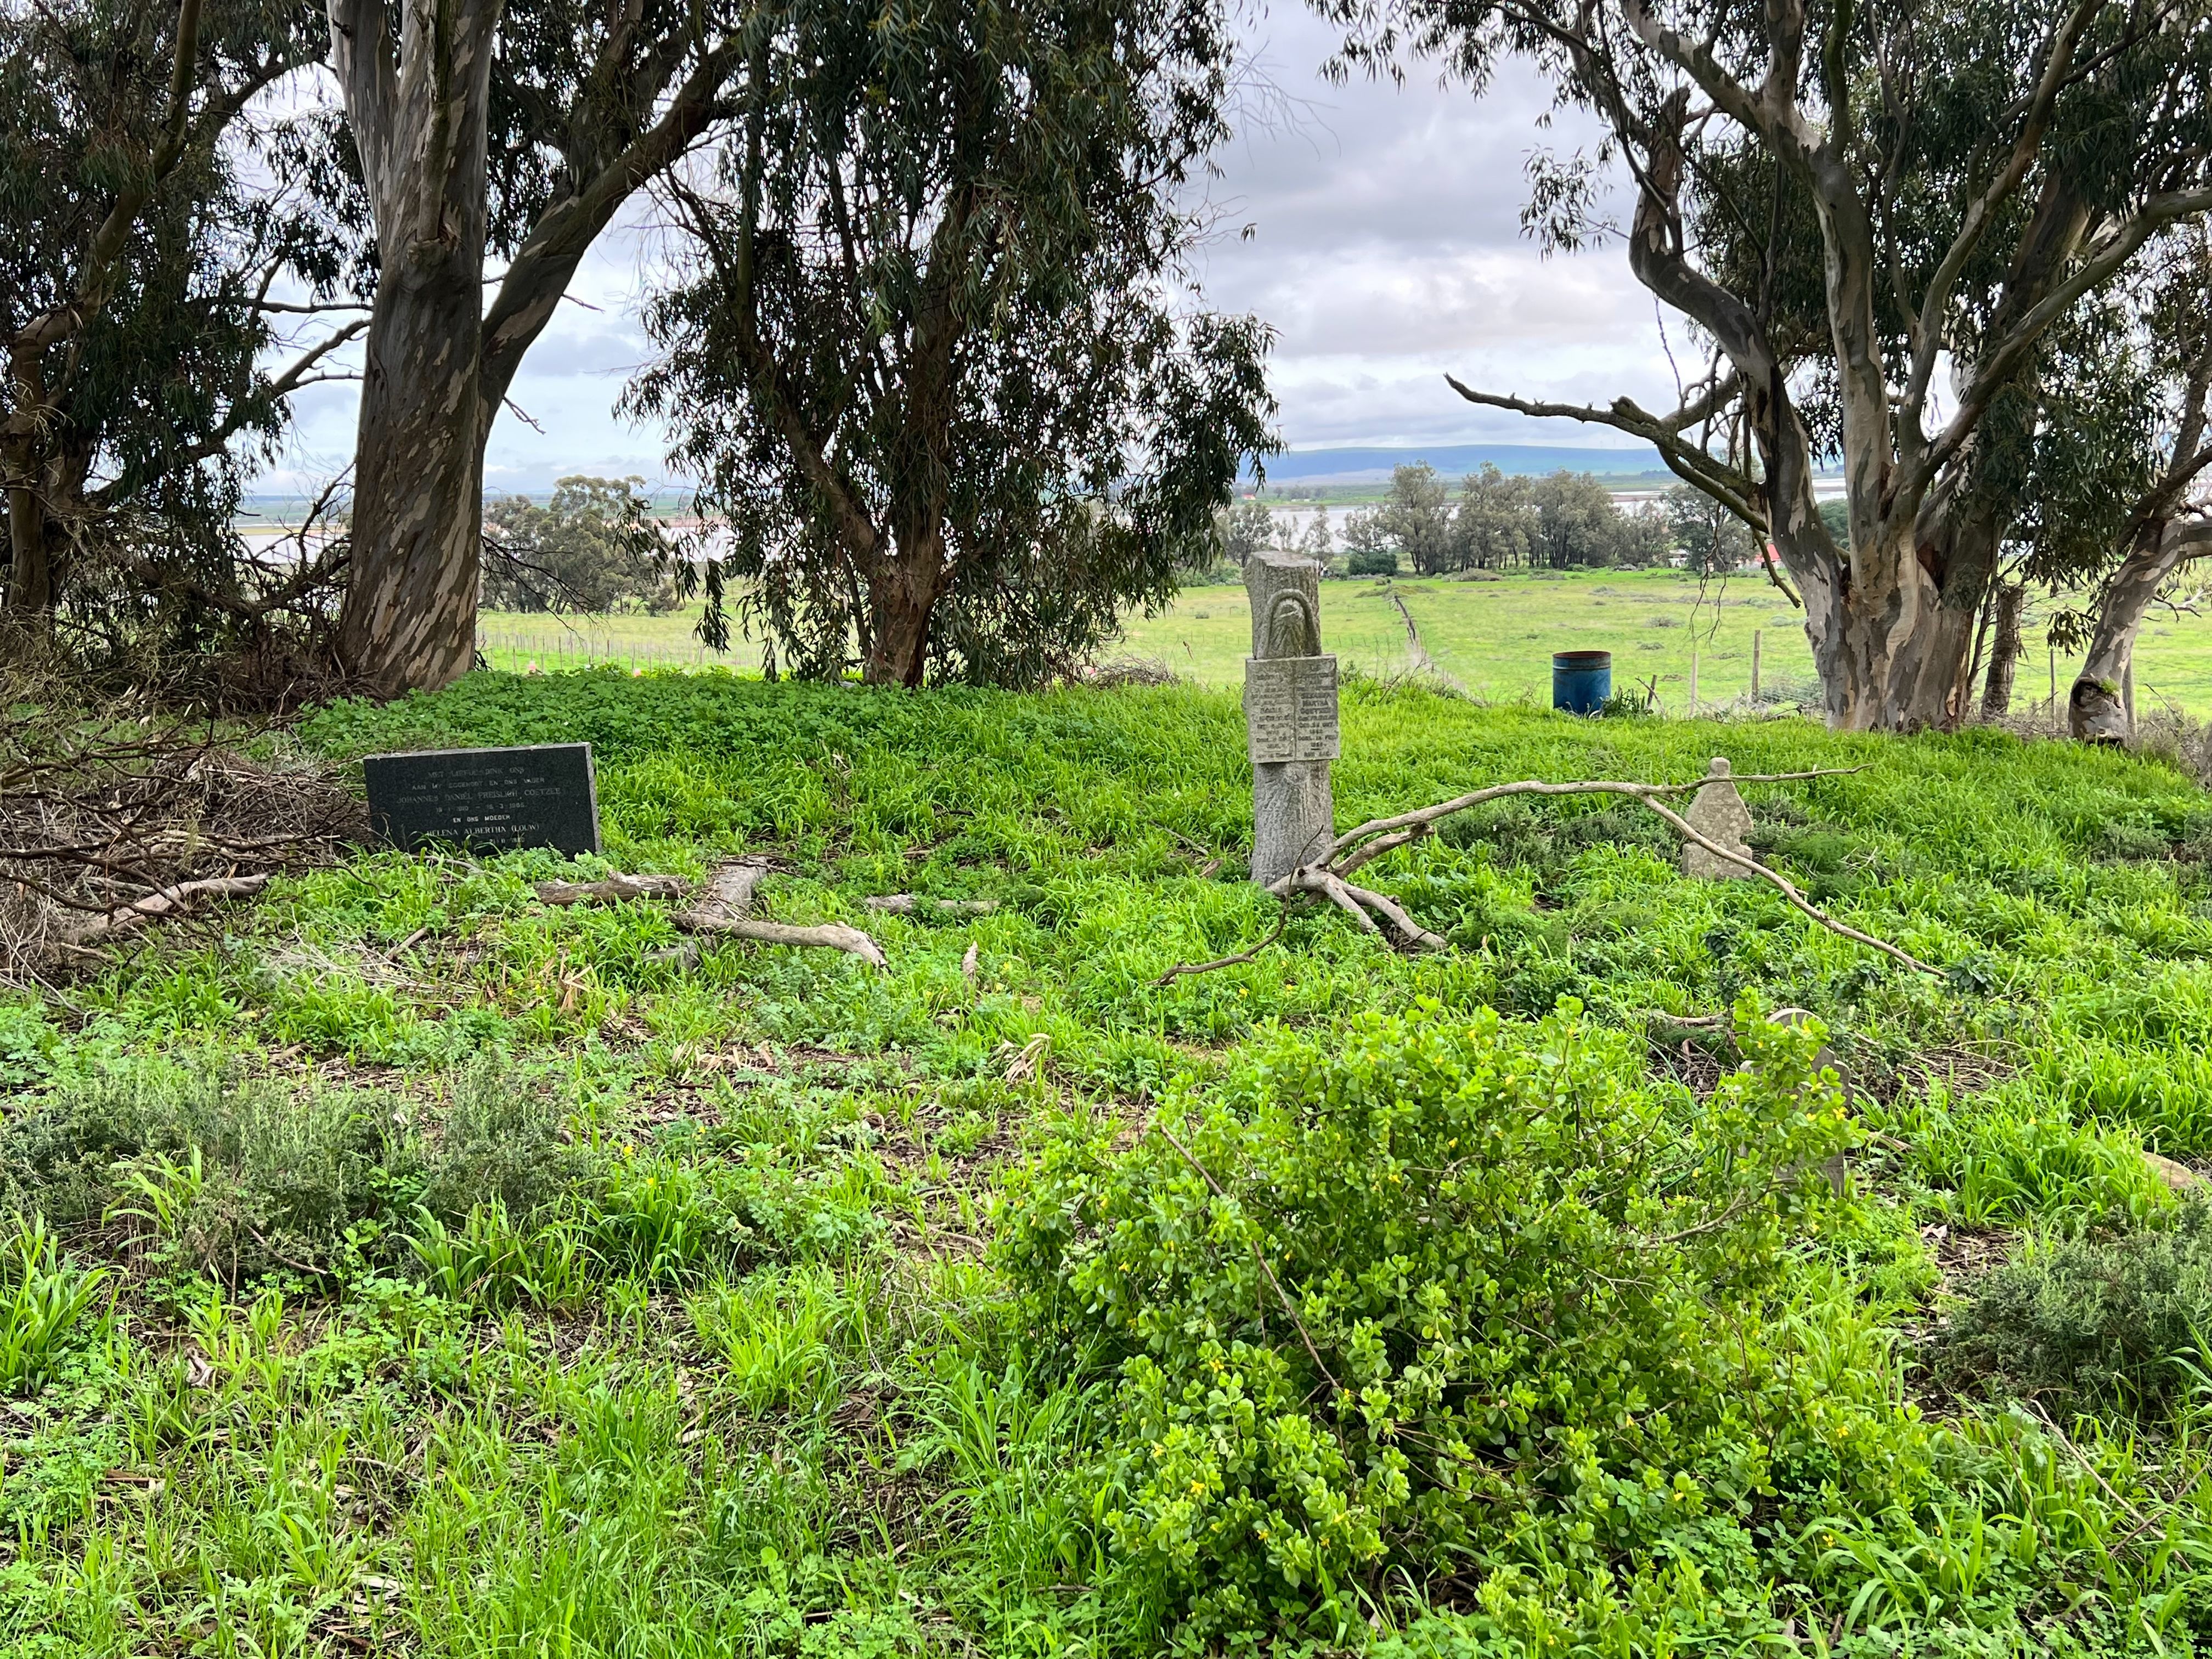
[482,571,2212,719]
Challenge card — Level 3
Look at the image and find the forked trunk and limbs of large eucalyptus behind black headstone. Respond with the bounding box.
[330,0,746,695]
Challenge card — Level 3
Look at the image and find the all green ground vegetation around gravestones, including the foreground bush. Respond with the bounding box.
[0,670,2212,1657]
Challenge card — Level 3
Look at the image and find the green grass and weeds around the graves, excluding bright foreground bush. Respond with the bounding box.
[13,668,2212,1659]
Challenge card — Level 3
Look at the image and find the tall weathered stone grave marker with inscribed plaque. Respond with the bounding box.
[1245,549,1338,887]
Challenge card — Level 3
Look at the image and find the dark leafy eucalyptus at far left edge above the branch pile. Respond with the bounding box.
[0,0,345,626]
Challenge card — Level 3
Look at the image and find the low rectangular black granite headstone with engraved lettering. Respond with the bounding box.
[360,743,600,854]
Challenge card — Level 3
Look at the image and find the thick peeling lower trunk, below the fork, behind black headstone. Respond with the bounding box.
[338,246,489,697]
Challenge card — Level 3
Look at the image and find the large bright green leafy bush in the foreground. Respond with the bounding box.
[997,1002,1854,1635]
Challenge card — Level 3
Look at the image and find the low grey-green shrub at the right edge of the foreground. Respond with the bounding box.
[1938,1199,2212,1411]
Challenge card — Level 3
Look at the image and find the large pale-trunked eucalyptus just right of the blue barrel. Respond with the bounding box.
[1380,0,2212,728]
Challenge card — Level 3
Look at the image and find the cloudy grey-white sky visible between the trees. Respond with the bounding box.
[261,4,1674,489]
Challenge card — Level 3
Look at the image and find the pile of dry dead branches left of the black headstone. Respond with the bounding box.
[0,675,365,989]
